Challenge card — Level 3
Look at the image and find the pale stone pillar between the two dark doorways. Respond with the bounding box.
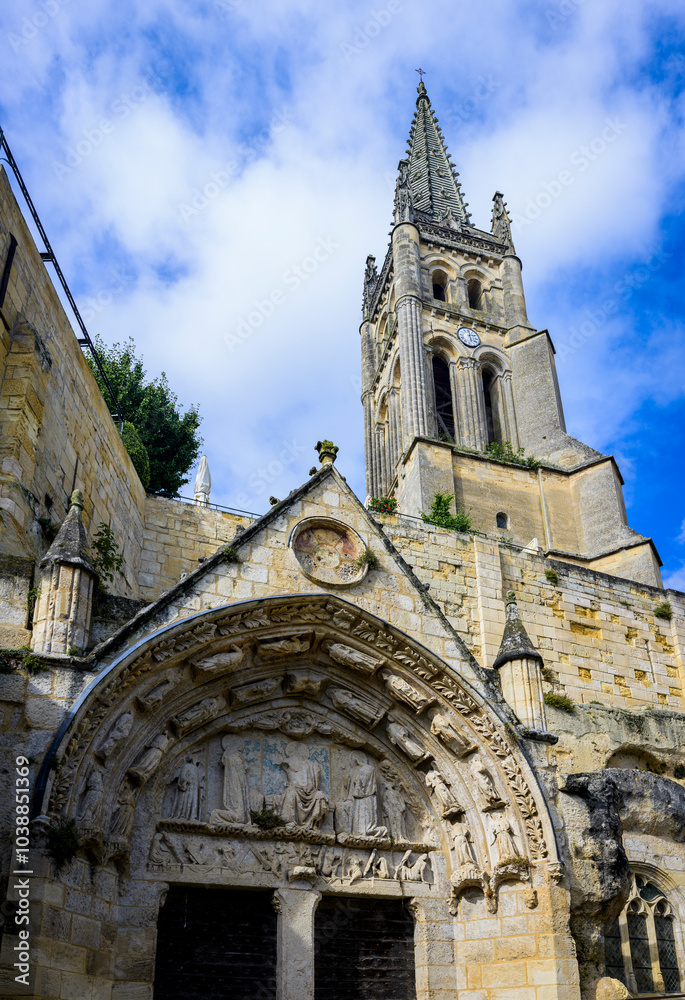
[273,888,321,1000]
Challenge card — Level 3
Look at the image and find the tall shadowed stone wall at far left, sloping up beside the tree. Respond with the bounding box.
[0,170,145,597]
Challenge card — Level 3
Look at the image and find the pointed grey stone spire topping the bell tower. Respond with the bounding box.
[395,80,471,228]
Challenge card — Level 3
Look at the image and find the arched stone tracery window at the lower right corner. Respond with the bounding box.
[604,875,680,996]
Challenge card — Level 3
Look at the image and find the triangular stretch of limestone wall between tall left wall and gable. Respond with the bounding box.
[138,495,252,601]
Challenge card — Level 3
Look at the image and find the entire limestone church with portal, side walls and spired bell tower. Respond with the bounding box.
[0,85,685,1000]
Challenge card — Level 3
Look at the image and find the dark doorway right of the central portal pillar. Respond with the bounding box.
[314,896,416,1000]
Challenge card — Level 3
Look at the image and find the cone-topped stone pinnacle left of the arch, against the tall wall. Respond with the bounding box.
[31,490,97,655]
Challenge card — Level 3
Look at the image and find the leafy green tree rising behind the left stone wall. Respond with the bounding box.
[86,337,202,497]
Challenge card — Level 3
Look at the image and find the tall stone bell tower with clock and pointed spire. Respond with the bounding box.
[361,86,661,586]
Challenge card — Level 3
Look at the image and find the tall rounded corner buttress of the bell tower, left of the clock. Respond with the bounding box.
[392,222,429,450]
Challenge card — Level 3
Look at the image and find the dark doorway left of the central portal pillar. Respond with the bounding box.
[154,886,277,1000]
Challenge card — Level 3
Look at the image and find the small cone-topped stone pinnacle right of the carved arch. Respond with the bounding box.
[493,590,547,731]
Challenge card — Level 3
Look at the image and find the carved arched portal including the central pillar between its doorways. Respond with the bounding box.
[36,594,560,1000]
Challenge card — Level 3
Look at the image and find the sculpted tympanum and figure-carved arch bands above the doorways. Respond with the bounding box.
[42,594,547,876]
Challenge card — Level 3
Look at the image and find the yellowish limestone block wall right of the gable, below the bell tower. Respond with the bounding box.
[383,516,685,711]
